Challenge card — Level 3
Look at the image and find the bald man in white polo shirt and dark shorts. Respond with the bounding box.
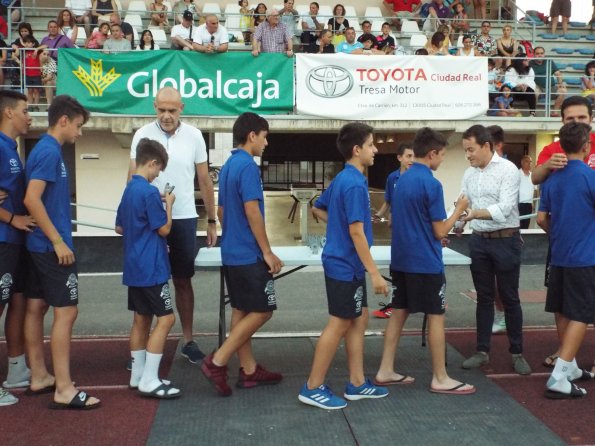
[128,87,217,364]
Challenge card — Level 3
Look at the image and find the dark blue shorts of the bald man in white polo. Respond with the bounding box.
[167,218,197,279]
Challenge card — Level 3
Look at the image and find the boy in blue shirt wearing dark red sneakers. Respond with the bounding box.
[200,113,283,396]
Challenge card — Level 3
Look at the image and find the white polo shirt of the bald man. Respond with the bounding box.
[130,121,207,220]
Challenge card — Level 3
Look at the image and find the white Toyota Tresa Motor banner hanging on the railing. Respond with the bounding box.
[296,54,489,120]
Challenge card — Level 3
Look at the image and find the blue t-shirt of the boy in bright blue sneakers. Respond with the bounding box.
[314,164,373,282]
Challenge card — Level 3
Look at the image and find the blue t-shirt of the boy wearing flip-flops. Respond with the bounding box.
[390,163,446,274]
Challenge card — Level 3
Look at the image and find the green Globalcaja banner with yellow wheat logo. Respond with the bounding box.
[57,49,294,116]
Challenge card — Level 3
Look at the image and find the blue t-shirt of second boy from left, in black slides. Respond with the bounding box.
[25,134,74,252]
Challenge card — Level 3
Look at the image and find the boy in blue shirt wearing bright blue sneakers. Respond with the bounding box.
[298,122,388,409]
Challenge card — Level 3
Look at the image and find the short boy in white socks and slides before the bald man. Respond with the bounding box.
[116,138,181,399]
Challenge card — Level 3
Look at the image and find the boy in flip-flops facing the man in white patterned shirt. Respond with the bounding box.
[375,127,475,395]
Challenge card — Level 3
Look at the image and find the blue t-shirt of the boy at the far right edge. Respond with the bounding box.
[539,160,595,268]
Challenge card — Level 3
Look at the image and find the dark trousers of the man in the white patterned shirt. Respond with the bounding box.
[469,234,523,354]
